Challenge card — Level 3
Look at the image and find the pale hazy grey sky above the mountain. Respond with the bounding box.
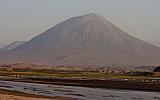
[0,0,160,43]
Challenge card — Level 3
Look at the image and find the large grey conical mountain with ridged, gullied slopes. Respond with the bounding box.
[0,14,160,66]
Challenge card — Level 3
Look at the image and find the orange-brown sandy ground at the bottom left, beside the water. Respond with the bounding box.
[0,89,69,100]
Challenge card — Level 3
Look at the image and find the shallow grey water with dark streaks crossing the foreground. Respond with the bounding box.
[0,81,160,100]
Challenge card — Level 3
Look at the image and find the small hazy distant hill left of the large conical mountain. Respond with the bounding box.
[0,41,26,52]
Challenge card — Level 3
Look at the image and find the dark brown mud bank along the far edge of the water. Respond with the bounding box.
[0,78,160,92]
